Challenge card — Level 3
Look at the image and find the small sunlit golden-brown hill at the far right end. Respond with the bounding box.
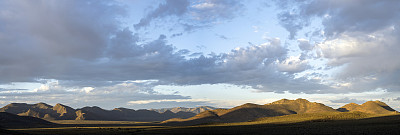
[338,101,398,114]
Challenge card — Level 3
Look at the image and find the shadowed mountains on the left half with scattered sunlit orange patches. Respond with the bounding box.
[0,103,196,121]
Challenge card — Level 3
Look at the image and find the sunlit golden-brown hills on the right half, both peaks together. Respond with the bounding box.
[163,99,398,125]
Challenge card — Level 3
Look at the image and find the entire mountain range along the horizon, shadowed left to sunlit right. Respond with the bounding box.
[0,99,398,125]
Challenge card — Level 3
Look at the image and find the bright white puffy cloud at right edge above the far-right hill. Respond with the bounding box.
[317,24,400,91]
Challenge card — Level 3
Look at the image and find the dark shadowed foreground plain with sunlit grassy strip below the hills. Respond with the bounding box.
[4,112,400,135]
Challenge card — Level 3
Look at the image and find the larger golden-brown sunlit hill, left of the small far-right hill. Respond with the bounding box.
[164,99,338,124]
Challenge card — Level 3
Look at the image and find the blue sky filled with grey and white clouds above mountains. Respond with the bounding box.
[0,0,400,110]
